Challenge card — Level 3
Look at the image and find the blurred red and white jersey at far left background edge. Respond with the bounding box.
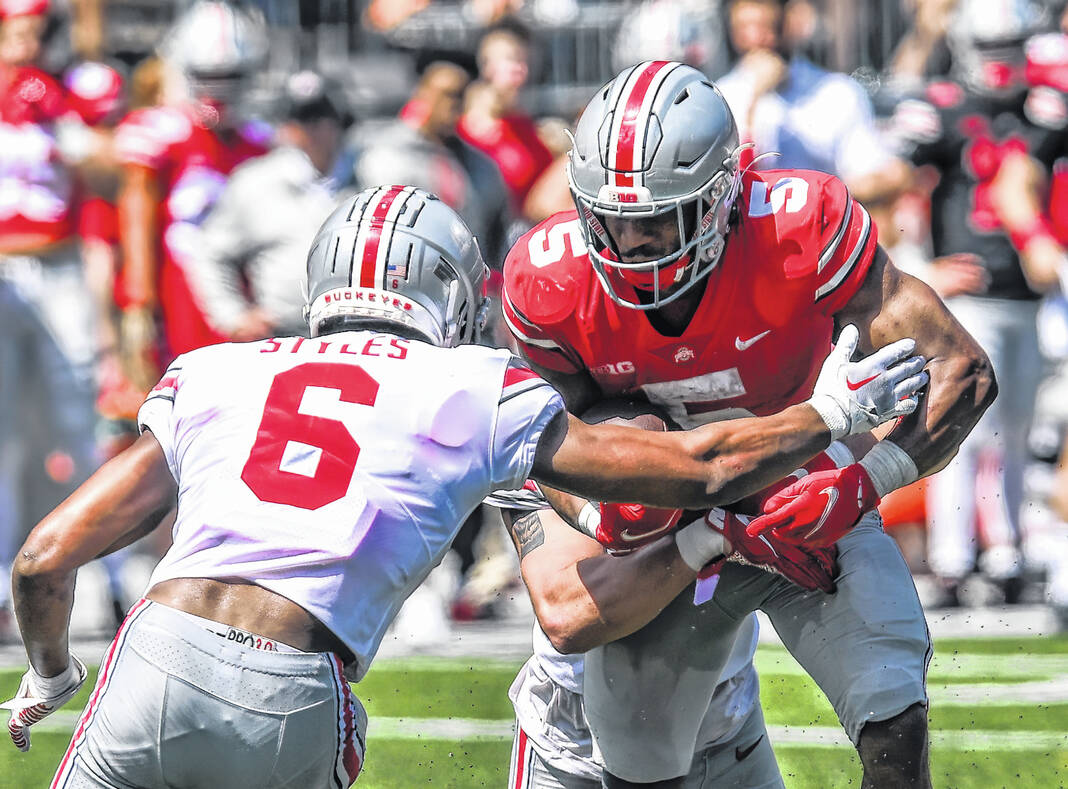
[0,66,74,243]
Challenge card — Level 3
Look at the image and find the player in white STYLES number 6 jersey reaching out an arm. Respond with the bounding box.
[3,187,926,788]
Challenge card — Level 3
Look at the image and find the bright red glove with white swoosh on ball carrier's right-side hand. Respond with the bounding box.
[745,463,879,548]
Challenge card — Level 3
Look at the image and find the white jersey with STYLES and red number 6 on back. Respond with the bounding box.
[138,332,564,678]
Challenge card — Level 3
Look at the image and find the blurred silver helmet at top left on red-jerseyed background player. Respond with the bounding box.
[159,0,268,104]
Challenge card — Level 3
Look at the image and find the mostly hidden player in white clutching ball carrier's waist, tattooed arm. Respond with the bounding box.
[490,491,783,789]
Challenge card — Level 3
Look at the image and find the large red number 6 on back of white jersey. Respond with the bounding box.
[241,362,378,509]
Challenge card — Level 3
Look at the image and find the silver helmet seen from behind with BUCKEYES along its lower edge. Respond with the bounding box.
[304,186,487,346]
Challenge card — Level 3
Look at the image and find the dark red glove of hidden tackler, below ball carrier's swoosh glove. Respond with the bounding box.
[705,508,838,594]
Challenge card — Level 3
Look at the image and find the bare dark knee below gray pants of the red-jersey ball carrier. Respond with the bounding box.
[857,704,930,789]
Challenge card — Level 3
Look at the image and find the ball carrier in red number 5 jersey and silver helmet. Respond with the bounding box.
[504,61,996,787]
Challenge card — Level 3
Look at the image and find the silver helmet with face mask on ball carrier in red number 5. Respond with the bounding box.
[567,61,741,310]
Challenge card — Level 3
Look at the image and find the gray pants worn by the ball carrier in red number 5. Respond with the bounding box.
[583,512,931,783]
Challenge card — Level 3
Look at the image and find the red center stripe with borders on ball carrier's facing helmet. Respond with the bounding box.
[604,60,680,187]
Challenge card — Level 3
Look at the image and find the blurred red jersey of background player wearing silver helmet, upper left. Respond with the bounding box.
[115,107,268,356]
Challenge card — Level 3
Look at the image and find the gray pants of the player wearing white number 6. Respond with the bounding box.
[52,600,367,789]
